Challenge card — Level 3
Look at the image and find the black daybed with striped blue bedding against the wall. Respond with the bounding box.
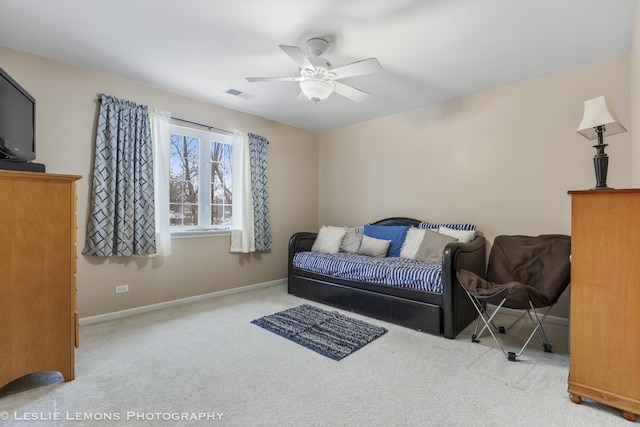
[288,218,485,338]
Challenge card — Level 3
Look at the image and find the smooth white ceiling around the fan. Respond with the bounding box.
[0,0,638,131]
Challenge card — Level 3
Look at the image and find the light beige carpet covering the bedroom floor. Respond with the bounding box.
[0,285,634,427]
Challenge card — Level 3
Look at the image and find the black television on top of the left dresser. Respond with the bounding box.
[0,68,42,170]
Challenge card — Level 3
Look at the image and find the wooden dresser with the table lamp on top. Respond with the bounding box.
[568,189,640,421]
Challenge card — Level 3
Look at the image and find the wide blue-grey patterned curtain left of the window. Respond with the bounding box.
[82,95,156,256]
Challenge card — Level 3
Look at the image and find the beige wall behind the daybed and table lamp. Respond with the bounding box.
[320,58,631,317]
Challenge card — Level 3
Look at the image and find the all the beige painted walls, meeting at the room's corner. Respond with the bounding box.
[0,41,640,317]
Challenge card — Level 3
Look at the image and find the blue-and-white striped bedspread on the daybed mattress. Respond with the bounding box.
[293,252,442,293]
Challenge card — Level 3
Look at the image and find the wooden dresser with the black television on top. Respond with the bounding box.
[0,170,80,387]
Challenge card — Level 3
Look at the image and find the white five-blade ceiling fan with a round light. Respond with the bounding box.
[247,38,382,104]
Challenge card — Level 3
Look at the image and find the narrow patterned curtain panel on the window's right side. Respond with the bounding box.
[248,133,272,251]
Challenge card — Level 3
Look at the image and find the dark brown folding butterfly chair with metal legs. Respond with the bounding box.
[457,234,571,361]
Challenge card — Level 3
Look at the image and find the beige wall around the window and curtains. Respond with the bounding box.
[0,48,318,317]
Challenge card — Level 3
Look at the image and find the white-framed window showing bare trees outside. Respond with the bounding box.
[169,125,233,232]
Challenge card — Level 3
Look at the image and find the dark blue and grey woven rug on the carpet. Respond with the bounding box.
[251,304,387,360]
